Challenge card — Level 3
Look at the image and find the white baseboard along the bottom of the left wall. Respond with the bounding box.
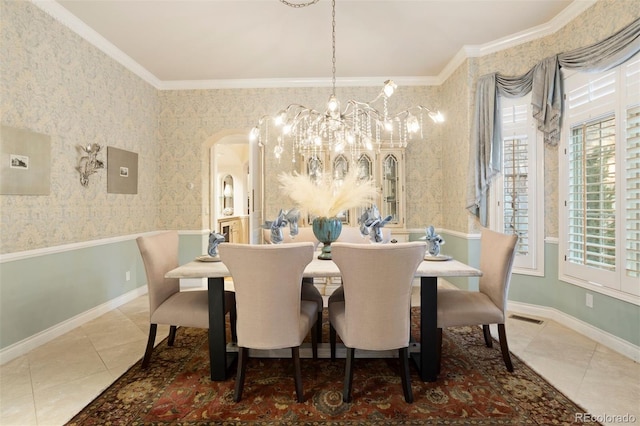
[0,285,147,365]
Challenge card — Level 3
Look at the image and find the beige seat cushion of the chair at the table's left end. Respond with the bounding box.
[151,290,209,328]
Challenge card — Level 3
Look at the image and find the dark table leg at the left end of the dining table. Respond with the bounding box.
[208,278,237,381]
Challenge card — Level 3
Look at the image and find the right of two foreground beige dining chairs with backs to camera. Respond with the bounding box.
[329,242,426,403]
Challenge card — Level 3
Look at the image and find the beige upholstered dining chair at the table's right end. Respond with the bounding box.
[437,229,518,372]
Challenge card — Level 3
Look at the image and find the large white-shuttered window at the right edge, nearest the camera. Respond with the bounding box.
[559,56,640,303]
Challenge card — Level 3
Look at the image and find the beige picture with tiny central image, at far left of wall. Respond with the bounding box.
[0,126,51,195]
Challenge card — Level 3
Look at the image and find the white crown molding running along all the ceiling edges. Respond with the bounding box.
[30,0,598,90]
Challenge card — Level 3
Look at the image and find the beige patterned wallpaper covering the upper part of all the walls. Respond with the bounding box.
[0,0,640,253]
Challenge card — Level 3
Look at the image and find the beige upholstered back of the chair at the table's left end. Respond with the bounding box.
[136,231,180,316]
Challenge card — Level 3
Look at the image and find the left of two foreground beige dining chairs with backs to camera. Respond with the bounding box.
[219,243,320,402]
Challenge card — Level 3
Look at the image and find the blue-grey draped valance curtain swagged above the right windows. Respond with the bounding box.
[467,19,640,226]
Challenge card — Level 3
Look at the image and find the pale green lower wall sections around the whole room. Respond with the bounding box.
[0,232,640,350]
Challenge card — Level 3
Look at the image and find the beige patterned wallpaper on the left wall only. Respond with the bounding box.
[0,1,160,253]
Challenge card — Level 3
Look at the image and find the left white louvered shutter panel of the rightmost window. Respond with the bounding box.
[565,71,616,287]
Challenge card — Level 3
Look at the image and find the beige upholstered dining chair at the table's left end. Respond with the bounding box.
[136,231,236,368]
